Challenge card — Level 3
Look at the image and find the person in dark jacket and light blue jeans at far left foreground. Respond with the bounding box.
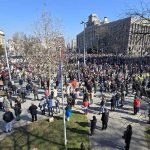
[3,109,14,133]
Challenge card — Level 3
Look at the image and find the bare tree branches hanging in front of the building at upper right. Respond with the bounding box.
[126,2,150,56]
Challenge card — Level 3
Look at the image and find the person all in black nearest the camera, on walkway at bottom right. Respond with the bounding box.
[122,125,132,150]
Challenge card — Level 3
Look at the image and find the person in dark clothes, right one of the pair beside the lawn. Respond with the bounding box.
[101,109,109,130]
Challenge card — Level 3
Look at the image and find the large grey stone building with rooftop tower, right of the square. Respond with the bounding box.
[77,14,150,55]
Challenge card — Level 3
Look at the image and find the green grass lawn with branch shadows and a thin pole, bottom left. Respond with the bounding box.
[0,112,90,150]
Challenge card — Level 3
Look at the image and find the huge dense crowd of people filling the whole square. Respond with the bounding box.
[0,57,150,150]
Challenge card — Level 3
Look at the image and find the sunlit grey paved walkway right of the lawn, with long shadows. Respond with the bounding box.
[88,94,148,150]
